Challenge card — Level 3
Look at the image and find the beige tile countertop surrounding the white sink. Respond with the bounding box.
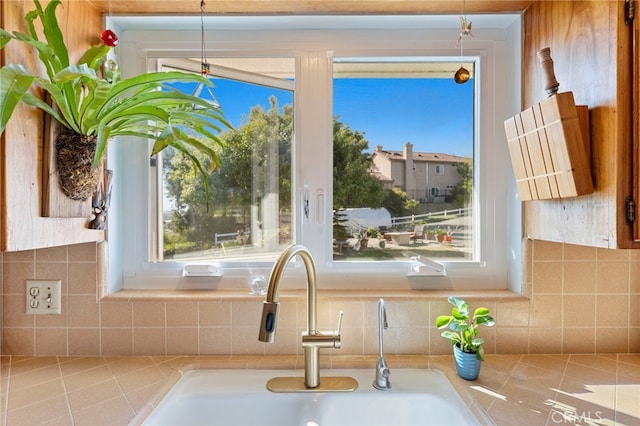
[0,354,640,426]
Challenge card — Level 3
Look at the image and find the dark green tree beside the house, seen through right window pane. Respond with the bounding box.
[333,119,384,209]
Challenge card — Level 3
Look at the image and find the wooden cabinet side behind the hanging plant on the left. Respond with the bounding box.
[0,0,104,251]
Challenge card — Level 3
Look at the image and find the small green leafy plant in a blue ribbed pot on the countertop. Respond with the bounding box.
[436,296,496,380]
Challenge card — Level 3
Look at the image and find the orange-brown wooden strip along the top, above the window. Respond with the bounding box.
[88,0,536,15]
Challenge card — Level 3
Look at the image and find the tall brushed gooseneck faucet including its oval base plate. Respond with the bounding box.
[258,245,358,392]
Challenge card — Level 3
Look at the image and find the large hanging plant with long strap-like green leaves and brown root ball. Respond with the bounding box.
[0,0,231,199]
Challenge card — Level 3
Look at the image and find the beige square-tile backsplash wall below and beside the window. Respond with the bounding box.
[0,241,640,356]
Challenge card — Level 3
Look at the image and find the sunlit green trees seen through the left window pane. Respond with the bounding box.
[164,97,293,255]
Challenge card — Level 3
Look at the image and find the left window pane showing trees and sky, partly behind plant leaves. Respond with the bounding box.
[160,58,294,261]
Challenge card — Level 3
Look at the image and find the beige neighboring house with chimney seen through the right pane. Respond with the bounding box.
[371,142,466,203]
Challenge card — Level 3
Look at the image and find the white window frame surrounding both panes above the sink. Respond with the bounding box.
[107,16,522,293]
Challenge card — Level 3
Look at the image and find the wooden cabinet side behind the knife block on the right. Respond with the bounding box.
[523,0,640,248]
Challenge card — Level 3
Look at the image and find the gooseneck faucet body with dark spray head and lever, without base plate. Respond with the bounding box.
[258,245,357,392]
